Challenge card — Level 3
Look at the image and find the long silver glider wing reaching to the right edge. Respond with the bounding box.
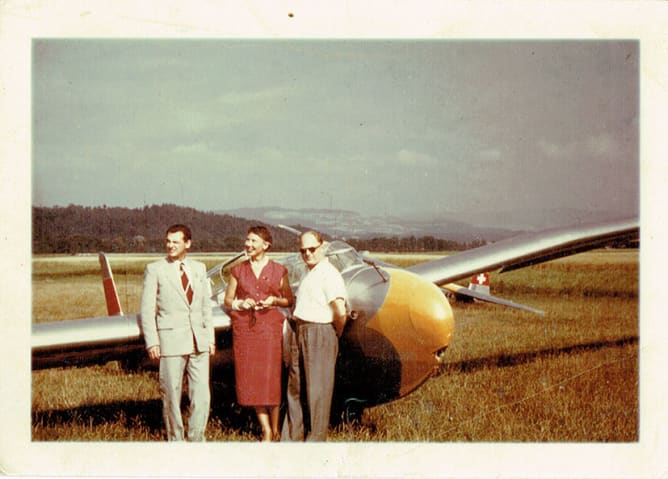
[406,219,640,286]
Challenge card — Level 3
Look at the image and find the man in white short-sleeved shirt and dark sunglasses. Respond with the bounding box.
[281,231,347,441]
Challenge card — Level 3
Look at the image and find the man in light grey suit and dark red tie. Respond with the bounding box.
[141,225,216,441]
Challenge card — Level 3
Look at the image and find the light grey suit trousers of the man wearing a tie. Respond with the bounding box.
[159,352,211,441]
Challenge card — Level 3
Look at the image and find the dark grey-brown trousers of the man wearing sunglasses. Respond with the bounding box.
[281,321,339,441]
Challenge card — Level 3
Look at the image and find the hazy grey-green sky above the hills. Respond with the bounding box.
[32,38,639,226]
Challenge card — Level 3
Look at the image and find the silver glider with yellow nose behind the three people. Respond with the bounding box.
[32,219,640,418]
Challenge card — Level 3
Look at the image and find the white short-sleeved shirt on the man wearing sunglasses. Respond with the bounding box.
[294,258,348,324]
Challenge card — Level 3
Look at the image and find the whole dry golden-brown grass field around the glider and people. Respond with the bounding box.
[32,250,639,442]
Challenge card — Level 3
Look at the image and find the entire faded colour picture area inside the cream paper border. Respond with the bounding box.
[2,1,664,477]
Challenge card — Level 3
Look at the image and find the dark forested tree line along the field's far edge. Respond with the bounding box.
[32,204,484,254]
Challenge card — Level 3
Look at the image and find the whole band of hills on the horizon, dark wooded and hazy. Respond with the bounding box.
[32,204,618,254]
